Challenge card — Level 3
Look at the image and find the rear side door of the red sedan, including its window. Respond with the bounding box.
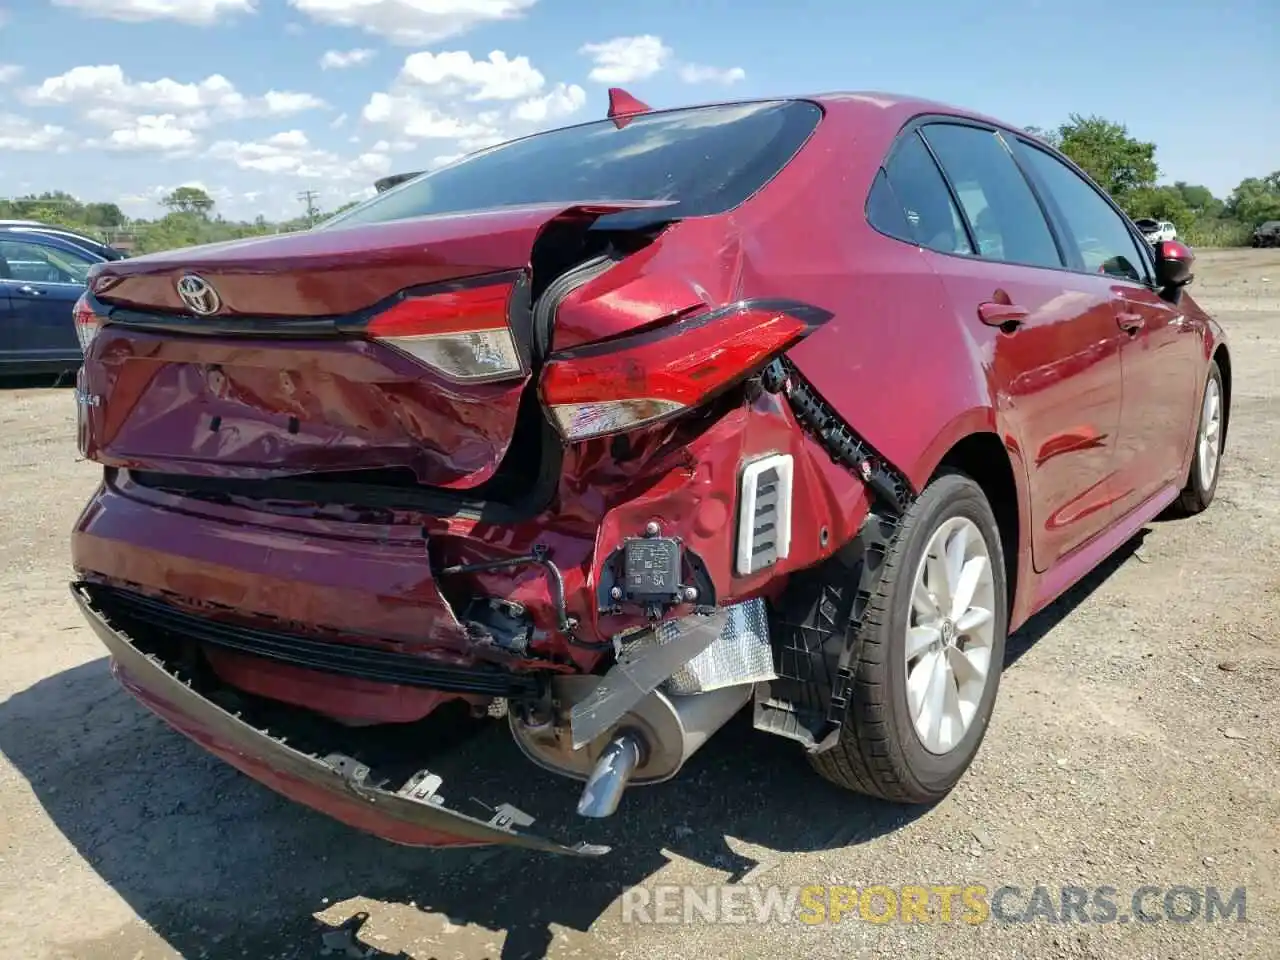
[919,120,1121,571]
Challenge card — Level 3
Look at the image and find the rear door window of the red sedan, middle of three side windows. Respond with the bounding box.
[923,123,1064,266]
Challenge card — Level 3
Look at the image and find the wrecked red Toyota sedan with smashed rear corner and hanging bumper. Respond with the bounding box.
[72,91,1231,855]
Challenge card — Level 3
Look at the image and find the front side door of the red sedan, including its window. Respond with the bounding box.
[1016,140,1203,513]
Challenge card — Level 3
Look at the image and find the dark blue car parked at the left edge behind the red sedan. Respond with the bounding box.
[0,228,108,376]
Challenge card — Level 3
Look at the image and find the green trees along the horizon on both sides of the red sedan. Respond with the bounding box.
[0,114,1280,253]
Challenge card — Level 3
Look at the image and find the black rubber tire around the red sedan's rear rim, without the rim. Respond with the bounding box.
[809,472,1009,804]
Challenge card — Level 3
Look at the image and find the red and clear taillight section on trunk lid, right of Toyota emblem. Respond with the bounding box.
[365,282,525,383]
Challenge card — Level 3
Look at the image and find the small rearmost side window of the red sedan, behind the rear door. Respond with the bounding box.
[867,133,973,253]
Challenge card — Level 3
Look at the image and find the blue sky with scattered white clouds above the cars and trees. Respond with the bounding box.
[0,0,1280,218]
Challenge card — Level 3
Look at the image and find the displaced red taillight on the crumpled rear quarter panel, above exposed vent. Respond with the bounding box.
[541,305,826,440]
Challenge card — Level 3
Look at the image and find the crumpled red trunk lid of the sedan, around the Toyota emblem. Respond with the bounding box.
[79,204,653,490]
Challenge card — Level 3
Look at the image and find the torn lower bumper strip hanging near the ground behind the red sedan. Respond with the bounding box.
[72,584,609,856]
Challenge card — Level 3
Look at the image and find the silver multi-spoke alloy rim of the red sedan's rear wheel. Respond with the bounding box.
[906,517,997,755]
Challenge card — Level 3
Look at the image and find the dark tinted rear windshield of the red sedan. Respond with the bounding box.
[323,100,822,227]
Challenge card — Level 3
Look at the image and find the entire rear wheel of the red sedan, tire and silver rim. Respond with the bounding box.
[812,474,1009,803]
